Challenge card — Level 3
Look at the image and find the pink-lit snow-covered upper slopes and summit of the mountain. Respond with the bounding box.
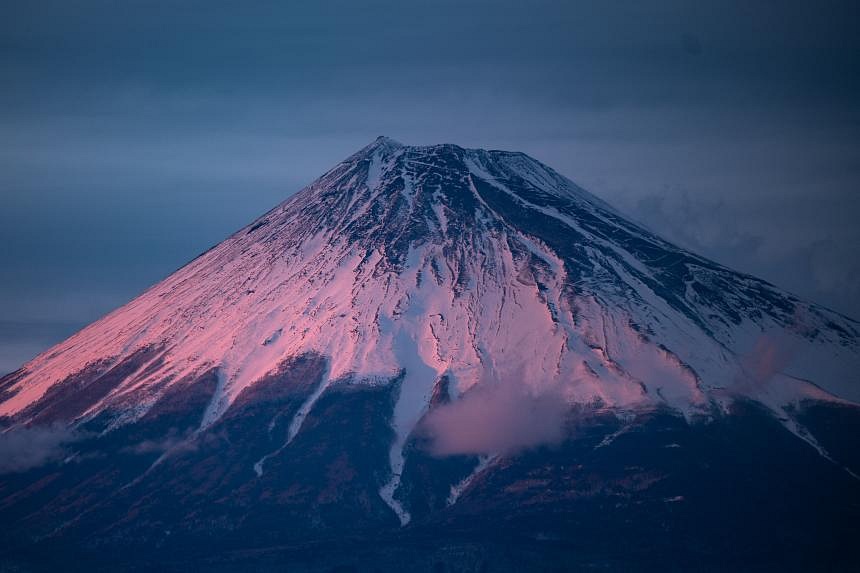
[0,138,860,504]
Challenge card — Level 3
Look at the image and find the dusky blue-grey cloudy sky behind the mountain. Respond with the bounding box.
[0,0,860,372]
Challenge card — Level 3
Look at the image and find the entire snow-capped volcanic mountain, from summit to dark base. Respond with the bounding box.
[0,138,860,571]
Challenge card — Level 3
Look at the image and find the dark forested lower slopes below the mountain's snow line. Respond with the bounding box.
[0,380,860,571]
